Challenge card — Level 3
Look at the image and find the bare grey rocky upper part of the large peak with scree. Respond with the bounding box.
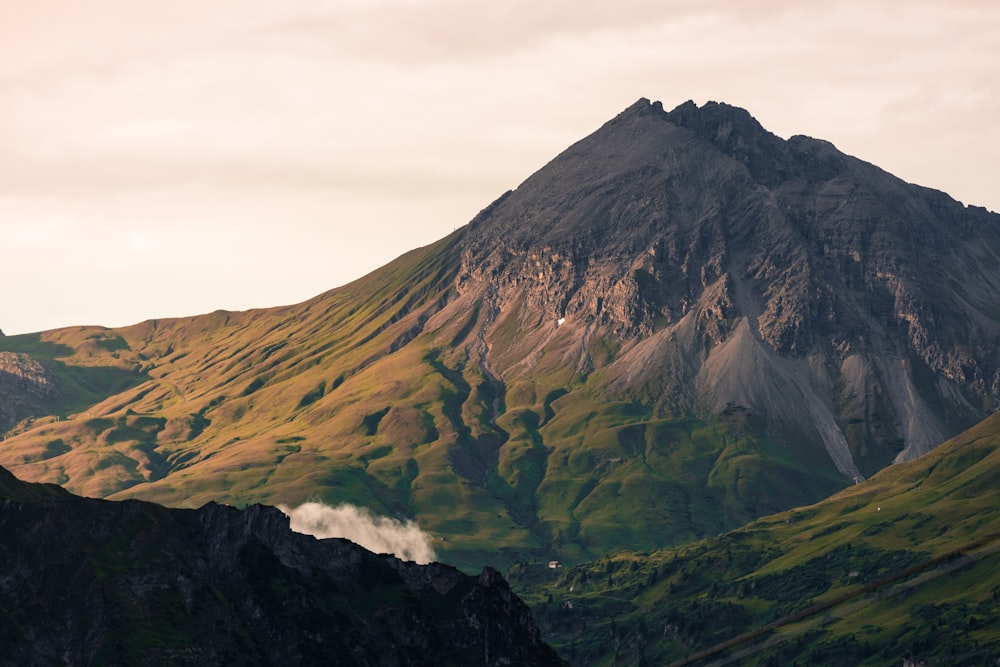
[453,100,1000,478]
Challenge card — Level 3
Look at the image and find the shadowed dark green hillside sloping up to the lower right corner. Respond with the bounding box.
[509,415,1000,665]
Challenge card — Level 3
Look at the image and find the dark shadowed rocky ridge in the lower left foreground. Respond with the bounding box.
[0,468,563,665]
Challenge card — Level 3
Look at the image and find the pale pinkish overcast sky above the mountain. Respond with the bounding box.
[0,0,1000,334]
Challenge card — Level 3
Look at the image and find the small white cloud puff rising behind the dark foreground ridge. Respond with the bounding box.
[278,503,437,565]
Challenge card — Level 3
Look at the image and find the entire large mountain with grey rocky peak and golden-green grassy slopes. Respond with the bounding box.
[0,100,1000,568]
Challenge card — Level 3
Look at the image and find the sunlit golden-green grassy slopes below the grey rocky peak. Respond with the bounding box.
[0,231,846,570]
